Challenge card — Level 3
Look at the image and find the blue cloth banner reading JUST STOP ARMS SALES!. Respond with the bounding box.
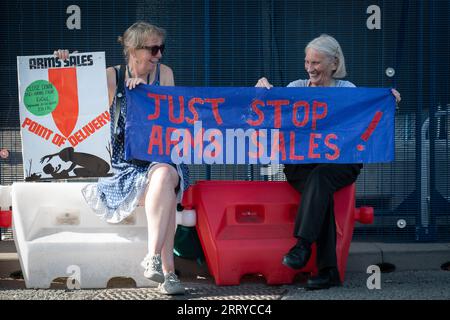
[125,85,395,164]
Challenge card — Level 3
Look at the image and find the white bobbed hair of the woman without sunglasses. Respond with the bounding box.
[305,34,347,78]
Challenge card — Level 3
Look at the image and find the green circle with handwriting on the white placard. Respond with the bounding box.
[23,80,59,116]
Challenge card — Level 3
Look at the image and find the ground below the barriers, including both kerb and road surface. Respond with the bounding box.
[0,241,450,300]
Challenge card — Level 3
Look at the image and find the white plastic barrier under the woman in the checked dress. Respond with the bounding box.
[12,183,195,288]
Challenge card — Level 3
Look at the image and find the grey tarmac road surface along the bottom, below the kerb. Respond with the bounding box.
[0,270,450,300]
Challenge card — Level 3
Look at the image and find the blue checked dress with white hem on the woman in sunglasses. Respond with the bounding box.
[82,64,189,223]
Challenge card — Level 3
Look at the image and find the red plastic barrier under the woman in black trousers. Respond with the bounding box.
[183,181,373,285]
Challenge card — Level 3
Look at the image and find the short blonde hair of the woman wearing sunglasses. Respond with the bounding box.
[118,21,166,60]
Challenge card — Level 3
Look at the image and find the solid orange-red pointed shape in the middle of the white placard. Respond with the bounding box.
[48,68,78,137]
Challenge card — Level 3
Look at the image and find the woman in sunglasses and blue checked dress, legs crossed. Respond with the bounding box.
[55,22,189,295]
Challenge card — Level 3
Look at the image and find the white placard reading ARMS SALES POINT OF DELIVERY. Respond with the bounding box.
[17,52,112,181]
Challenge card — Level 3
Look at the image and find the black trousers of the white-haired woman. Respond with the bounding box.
[284,163,362,270]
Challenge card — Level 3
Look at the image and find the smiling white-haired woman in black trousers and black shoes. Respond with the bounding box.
[256,34,401,289]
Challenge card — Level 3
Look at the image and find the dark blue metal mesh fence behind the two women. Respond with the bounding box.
[0,0,450,242]
